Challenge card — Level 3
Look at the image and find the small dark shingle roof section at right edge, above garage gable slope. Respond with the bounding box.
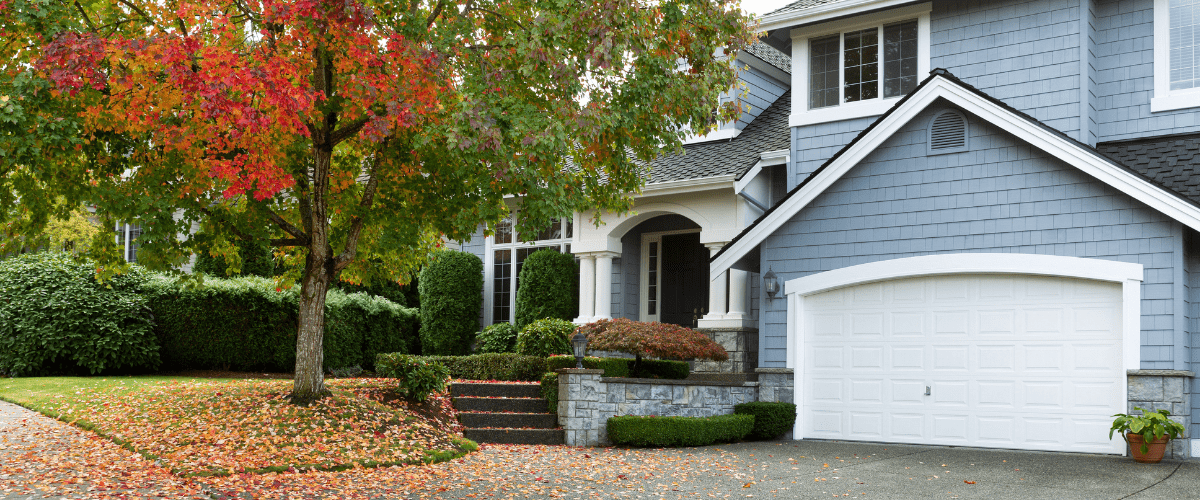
[1096,134,1200,203]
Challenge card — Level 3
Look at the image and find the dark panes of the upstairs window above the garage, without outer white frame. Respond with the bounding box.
[809,19,918,109]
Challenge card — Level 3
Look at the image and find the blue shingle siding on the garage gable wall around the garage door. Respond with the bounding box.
[761,109,1182,369]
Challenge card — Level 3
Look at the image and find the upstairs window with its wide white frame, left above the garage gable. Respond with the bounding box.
[790,4,930,127]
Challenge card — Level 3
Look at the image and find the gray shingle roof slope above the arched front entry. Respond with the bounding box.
[647,91,792,183]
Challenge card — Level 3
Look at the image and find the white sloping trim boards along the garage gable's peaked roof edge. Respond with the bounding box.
[709,76,1200,276]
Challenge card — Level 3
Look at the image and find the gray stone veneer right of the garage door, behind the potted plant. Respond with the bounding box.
[1114,369,1195,458]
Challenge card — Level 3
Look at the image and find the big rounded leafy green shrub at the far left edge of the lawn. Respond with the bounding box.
[0,252,160,375]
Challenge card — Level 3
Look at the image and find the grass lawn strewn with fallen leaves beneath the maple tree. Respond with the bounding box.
[0,376,475,475]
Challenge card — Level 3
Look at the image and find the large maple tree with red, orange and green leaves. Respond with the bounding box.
[0,0,754,404]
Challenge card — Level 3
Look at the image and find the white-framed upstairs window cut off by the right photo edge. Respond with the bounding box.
[1150,0,1200,113]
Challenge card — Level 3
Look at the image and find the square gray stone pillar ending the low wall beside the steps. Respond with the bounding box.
[556,368,607,446]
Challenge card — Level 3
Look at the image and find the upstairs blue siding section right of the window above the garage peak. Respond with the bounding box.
[930,0,1082,138]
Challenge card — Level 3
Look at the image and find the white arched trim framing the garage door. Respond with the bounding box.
[784,253,1144,439]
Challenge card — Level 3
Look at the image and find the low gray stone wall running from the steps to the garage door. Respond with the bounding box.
[558,368,794,446]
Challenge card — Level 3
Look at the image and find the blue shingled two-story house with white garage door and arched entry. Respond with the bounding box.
[448,0,1200,457]
